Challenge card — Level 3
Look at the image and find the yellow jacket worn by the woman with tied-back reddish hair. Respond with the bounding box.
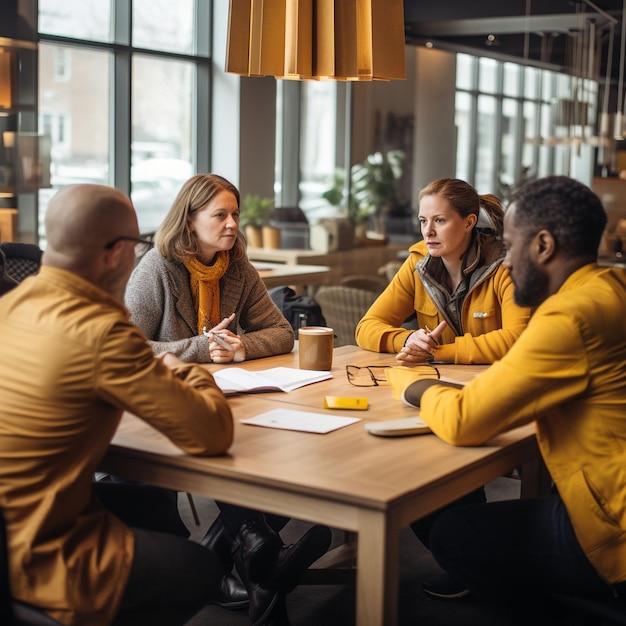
[355,241,530,364]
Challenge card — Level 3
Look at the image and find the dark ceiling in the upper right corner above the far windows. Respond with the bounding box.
[404,0,624,83]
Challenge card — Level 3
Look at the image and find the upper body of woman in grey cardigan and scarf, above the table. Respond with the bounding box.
[125,174,294,363]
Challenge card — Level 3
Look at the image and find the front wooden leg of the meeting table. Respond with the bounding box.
[356,511,399,626]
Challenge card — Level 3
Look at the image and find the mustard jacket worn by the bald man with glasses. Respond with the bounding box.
[0,266,233,626]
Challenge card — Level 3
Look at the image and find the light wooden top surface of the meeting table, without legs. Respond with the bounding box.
[113,346,534,510]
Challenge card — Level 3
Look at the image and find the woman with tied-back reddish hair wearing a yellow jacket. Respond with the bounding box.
[356,178,530,365]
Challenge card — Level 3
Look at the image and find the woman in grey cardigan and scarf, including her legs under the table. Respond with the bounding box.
[125,174,331,626]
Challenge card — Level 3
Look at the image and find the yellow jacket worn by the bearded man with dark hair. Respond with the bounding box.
[420,264,626,583]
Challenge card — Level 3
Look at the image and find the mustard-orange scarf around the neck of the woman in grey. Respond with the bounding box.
[183,251,230,335]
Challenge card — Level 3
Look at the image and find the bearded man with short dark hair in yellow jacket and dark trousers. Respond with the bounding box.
[405,176,626,624]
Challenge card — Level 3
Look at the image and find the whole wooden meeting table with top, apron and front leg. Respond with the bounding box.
[102,346,540,626]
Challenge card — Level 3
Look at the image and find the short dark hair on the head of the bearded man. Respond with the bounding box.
[509,176,607,257]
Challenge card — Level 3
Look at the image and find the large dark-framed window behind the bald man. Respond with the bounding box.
[39,0,210,237]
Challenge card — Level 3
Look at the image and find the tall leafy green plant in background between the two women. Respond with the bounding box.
[322,150,405,239]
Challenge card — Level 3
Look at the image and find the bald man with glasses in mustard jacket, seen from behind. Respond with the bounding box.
[0,185,233,626]
